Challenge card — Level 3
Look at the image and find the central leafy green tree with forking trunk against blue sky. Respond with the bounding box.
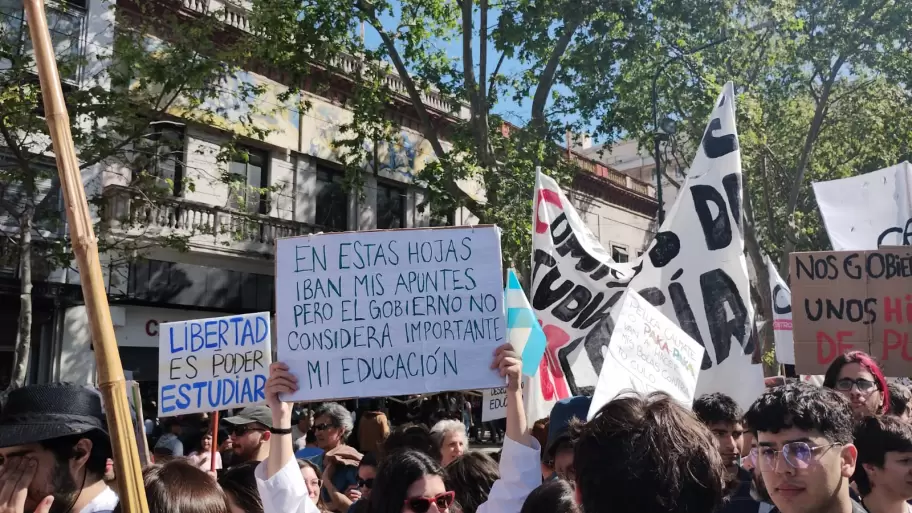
[253,0,728,272]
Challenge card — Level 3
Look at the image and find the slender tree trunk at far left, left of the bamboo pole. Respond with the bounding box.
[10,201,35,388]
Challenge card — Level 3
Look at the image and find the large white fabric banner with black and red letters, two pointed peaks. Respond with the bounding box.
[526,83,764,410]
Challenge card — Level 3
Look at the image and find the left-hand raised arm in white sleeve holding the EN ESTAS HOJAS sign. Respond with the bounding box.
[266,362,298,478]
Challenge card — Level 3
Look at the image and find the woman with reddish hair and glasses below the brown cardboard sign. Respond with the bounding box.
[823,351,890,420]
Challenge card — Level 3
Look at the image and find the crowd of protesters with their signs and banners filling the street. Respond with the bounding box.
[0,57,912,513]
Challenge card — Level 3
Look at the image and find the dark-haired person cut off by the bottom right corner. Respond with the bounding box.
[854,416,912,513]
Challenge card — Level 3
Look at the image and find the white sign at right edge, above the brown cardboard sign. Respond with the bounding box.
[814,162,912,251]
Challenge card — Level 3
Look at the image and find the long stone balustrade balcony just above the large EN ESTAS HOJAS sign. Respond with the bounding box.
[102,185,333,258]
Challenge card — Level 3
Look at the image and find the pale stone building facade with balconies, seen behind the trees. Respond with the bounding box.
[0,0,656,393]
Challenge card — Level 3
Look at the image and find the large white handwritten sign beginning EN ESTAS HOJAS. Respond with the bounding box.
[276,226,506,401]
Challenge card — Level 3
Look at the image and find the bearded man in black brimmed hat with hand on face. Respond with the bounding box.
[0,383,118,513]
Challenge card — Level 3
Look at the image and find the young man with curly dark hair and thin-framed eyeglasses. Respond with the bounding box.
[745,383,864,513]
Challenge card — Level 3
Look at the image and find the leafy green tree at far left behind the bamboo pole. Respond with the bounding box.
[0,2,266,387]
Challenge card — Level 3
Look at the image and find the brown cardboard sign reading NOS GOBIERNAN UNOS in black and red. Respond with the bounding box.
[790,246,912,377]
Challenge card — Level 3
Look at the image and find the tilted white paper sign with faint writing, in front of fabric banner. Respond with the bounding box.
[588,290,705,420]
